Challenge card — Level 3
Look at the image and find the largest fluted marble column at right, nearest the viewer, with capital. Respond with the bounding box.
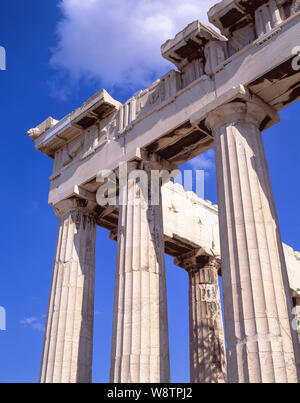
[207,98,299,383]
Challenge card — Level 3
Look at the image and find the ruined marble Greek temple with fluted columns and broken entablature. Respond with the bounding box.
[28,0,300,383]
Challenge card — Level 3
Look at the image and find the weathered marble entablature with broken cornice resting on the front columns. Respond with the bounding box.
[28,0,300,205]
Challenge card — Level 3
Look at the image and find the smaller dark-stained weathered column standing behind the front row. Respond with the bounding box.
[175,252,226,383]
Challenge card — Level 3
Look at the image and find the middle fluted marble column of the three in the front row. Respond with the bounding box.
[110,159,170,383]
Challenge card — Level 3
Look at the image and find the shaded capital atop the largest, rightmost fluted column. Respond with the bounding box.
[206,94,280,132]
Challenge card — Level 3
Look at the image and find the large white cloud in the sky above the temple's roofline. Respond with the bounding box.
[51,0,217,96]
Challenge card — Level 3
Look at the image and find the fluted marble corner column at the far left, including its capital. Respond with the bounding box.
[40,200,96,383]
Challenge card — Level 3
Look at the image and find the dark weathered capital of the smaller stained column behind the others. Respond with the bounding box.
[174,250,221,272]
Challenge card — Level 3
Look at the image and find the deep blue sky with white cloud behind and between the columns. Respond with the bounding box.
[0,0,300,382]
